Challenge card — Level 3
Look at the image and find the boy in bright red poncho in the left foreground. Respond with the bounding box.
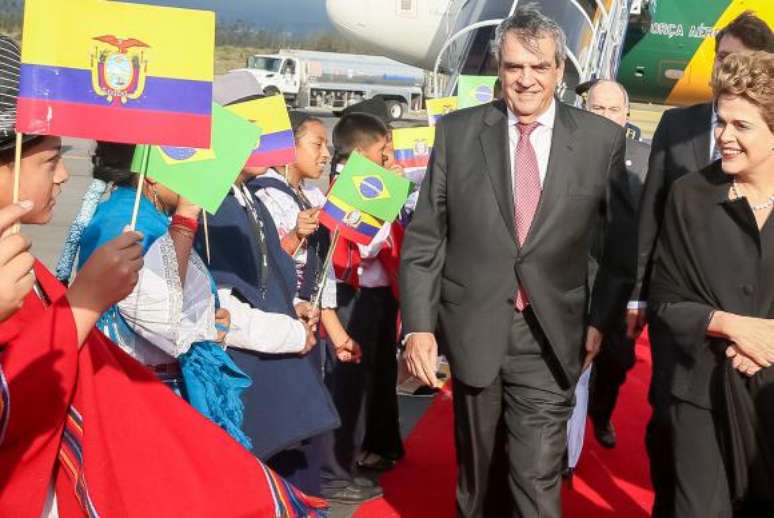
[0,37,324,518]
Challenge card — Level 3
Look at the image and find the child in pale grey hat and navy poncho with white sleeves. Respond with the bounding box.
[196,85,339,495]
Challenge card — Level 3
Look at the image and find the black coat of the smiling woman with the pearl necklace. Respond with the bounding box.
[648,165,774,408]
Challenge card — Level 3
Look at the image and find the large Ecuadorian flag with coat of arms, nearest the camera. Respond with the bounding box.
[16,0,215,148]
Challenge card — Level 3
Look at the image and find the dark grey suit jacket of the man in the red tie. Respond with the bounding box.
[400,101,636,387]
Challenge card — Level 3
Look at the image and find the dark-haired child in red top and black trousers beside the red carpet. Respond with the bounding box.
[324,112,410,501]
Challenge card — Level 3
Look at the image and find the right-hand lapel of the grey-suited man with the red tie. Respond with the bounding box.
[523,100,577,252]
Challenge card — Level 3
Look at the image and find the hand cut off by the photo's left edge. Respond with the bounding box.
[0,202,35,322]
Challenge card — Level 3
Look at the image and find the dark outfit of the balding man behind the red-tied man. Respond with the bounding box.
[589,139,650,425]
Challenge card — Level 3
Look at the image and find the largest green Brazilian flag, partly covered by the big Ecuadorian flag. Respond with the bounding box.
[132,103,261,214]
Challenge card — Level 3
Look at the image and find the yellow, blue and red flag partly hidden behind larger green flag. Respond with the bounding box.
[226,95,296,167]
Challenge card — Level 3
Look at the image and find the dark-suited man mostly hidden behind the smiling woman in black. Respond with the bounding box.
[627,11,774,518]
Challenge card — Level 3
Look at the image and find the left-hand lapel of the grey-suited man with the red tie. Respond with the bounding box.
[479,101,516,241]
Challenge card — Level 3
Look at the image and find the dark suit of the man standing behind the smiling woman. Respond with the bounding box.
[632,103,712,518]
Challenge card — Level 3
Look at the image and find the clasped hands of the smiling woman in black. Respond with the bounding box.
[709,311,774,368]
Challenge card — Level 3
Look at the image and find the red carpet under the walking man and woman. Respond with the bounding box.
[355,333,653,518]
